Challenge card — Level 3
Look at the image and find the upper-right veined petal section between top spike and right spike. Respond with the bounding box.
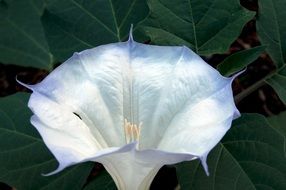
[132,44,236,149]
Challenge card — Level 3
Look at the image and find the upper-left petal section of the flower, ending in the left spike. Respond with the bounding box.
[31,47,125,147]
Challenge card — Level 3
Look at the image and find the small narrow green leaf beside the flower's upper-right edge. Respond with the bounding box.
[217,46,266,76]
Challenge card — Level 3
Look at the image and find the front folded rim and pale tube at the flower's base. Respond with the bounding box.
[95,144,197,190]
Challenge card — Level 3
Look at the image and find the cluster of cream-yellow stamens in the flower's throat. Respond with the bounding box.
[124,119,142,146]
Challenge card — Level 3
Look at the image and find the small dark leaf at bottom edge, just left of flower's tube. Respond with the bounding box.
[83,171,117,190]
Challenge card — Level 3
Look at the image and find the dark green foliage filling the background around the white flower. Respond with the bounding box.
[0,0,286,190]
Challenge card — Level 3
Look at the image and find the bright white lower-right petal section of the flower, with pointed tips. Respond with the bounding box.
[158,76,239,173]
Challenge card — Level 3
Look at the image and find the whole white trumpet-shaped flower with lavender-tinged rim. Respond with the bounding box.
[19,35,239,190]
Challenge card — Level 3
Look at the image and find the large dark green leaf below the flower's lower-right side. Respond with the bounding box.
[176,114,286,190]
